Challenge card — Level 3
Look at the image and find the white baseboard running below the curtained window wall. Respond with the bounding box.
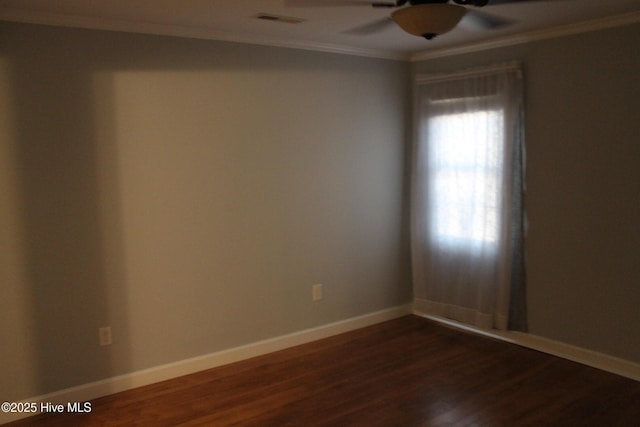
[413,308,640,381]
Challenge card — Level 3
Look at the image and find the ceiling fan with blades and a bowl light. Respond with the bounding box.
[284,0,556,40]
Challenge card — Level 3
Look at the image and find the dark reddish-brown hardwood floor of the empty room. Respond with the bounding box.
[10,316,640,427]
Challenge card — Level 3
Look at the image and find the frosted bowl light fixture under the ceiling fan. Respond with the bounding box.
[391,4,467,39]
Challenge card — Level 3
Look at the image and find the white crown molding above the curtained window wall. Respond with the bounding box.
[409,12,640,62]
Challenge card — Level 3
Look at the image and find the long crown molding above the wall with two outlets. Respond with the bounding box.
[0,8,409,61]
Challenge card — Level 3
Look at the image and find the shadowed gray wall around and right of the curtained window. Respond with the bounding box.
[414,25,640,362]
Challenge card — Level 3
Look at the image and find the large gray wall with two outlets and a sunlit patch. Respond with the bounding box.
[0,23,411,400]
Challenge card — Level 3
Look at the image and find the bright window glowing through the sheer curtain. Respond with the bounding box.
[428,105,504,248]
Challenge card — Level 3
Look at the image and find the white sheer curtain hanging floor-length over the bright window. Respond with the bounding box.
[411,63,526,330]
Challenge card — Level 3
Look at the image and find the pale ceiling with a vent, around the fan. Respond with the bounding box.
[0,0,640,59]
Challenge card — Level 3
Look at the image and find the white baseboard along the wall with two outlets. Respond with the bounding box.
[0,304,412,424]
